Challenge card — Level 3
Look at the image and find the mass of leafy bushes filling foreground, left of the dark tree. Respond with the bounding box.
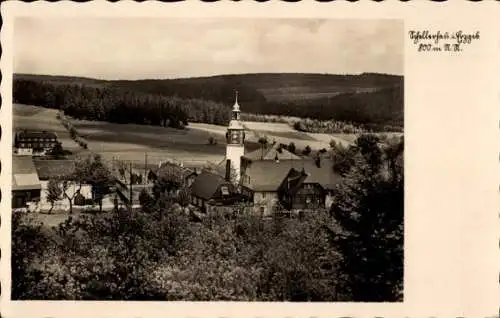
[13,206,344,301]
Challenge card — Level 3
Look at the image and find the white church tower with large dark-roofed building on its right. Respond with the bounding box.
[208,95,341,215]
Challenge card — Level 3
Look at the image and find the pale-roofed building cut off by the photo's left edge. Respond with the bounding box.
[12,156,42,209]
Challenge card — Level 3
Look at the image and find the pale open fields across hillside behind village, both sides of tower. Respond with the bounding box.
[14,104,401,169]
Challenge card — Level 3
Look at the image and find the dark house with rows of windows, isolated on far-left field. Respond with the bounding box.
[14,130,57,156]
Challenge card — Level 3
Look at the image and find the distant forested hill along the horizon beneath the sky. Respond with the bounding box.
[14,73,404,130]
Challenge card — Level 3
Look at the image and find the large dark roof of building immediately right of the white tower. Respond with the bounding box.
[242,158,340,191]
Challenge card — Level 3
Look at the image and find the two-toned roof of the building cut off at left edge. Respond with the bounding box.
[12,156,41,191]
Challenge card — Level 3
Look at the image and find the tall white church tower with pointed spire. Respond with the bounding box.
[226,92,245,182]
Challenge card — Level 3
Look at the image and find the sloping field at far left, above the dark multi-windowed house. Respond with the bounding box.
[12,104,82,154]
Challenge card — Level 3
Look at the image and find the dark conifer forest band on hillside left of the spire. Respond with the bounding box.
[13,79,230,128]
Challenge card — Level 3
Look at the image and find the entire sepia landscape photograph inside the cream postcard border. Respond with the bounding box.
[9,16,407,303]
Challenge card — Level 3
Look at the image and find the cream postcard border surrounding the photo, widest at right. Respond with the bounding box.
[0,0,500,317]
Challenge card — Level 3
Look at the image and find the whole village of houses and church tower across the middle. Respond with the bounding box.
[12,92,340,220]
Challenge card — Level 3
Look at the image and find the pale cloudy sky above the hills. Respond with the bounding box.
[14,17,404,79]
